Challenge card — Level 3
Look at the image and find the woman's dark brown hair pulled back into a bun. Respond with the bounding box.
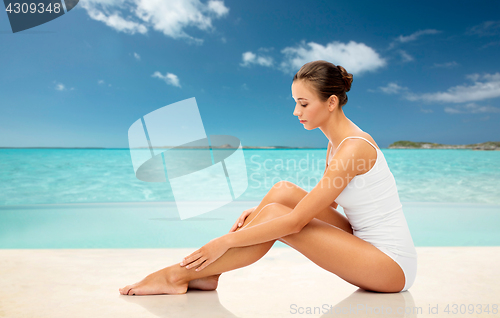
[293,60,352,107]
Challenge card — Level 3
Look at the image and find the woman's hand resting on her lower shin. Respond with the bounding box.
[180,236,229,271]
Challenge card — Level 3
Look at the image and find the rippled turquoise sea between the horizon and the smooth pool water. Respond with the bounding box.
[0,149,500,205]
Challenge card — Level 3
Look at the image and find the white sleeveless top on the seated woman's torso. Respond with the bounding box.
[328,136,417,258]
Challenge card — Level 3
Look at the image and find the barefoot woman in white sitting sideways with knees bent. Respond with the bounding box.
[120,61,417,295]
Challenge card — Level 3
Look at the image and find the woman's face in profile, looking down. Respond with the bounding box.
[292,80,330,130]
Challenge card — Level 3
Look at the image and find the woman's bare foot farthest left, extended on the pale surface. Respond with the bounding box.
[120,265,188,295]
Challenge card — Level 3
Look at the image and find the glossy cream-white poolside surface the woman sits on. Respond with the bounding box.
[0,247,500,318]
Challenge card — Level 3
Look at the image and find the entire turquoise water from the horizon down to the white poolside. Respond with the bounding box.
[0,149,500,248]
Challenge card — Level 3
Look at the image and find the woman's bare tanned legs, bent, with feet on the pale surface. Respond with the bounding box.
[120,183,405,295]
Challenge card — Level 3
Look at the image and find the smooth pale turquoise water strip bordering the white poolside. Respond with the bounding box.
[0,201,500,249]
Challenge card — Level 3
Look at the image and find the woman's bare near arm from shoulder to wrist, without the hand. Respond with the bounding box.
[222,140,362,247]
